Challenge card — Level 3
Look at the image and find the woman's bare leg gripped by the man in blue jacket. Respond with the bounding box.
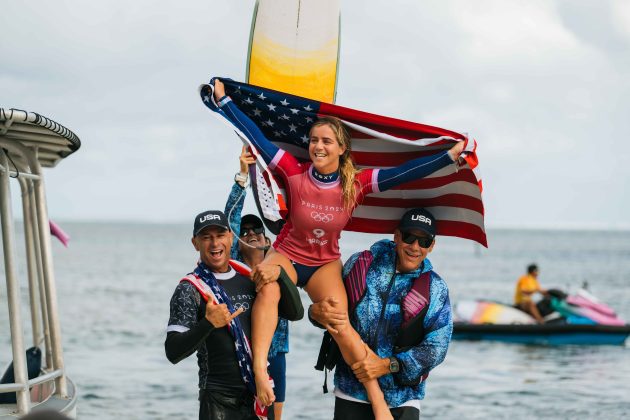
[305,260,393,420]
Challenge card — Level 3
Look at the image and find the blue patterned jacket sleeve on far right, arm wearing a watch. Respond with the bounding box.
[394,275,453,385]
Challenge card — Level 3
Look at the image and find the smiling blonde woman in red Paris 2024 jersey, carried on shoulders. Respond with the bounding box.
[214,79,464,420]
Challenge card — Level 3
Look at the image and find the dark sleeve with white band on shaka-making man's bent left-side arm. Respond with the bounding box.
[164,282,214,363]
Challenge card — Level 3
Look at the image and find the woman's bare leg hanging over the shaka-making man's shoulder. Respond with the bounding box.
[252,248,297,405]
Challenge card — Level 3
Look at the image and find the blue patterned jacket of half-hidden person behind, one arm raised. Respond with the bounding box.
[224,182,289,359]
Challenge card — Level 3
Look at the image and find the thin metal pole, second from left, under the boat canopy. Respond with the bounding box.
[18,175,42,347]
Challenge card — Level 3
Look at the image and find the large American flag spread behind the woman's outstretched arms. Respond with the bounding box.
[200,79,487,247]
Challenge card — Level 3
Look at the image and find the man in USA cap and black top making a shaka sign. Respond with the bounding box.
[165,210,273,420]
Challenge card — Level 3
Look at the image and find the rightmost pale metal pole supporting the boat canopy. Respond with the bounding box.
[29,151,68,398]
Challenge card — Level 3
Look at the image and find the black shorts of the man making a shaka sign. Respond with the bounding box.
[199,389,274,420]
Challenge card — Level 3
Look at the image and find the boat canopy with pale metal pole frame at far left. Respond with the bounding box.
[0,108,81,417]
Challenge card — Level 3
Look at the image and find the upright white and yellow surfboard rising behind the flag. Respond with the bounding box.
[246,0,341,103]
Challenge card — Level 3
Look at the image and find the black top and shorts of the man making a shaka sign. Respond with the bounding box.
[165,268,273,420]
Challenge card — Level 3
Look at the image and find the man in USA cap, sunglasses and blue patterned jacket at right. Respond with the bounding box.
[309,208,453,420]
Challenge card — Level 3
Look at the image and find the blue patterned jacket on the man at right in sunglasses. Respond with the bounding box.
[335,240,453,407]
